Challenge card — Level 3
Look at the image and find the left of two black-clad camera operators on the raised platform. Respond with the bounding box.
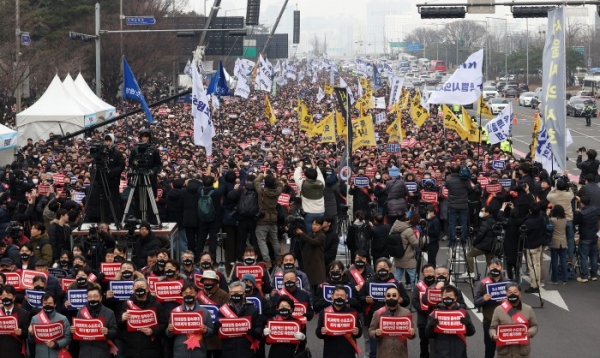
[85,134,125,222]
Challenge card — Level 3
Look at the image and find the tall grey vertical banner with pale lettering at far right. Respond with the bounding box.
[542,7,567,170]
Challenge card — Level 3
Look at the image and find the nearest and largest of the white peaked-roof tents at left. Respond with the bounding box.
[17,75,96,146]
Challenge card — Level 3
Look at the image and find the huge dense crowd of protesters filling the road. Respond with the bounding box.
[0,60,600,358]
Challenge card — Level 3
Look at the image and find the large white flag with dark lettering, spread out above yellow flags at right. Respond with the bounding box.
[427,50,483,104]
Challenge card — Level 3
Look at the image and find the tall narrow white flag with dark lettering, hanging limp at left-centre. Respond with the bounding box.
[192,61,215,156]
